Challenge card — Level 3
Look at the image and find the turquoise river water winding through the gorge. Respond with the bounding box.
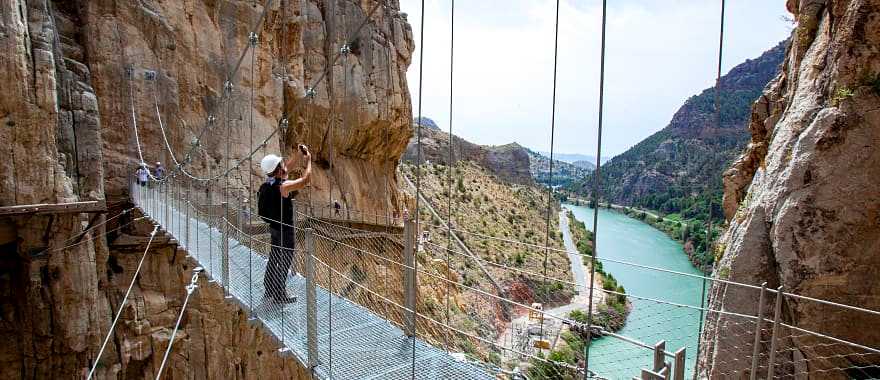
[563,204,703,379]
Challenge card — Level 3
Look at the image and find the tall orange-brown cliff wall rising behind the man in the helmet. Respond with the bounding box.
[89,0,414,213]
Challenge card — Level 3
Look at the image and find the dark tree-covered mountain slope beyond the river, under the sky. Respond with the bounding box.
[569,41,787,218]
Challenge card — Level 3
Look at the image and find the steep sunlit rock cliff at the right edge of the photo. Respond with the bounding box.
[701,0,880,378]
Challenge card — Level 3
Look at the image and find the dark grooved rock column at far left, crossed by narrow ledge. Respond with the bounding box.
[0,0,109,378]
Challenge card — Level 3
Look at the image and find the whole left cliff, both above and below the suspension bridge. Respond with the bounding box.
[0,0,414,378]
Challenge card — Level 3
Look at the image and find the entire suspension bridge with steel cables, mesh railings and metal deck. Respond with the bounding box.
[16,0,880,380]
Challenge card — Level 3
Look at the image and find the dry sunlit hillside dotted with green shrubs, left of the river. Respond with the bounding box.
[400,161,574,360]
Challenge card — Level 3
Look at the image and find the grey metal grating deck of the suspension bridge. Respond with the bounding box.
[132,183,495,379]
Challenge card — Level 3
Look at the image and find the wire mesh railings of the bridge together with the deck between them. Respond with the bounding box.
[131,179,880,379]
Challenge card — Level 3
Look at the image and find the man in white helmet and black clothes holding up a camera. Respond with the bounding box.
[257,145,312,304]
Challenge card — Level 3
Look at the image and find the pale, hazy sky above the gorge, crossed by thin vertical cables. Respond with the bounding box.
[400,0,793,160]
